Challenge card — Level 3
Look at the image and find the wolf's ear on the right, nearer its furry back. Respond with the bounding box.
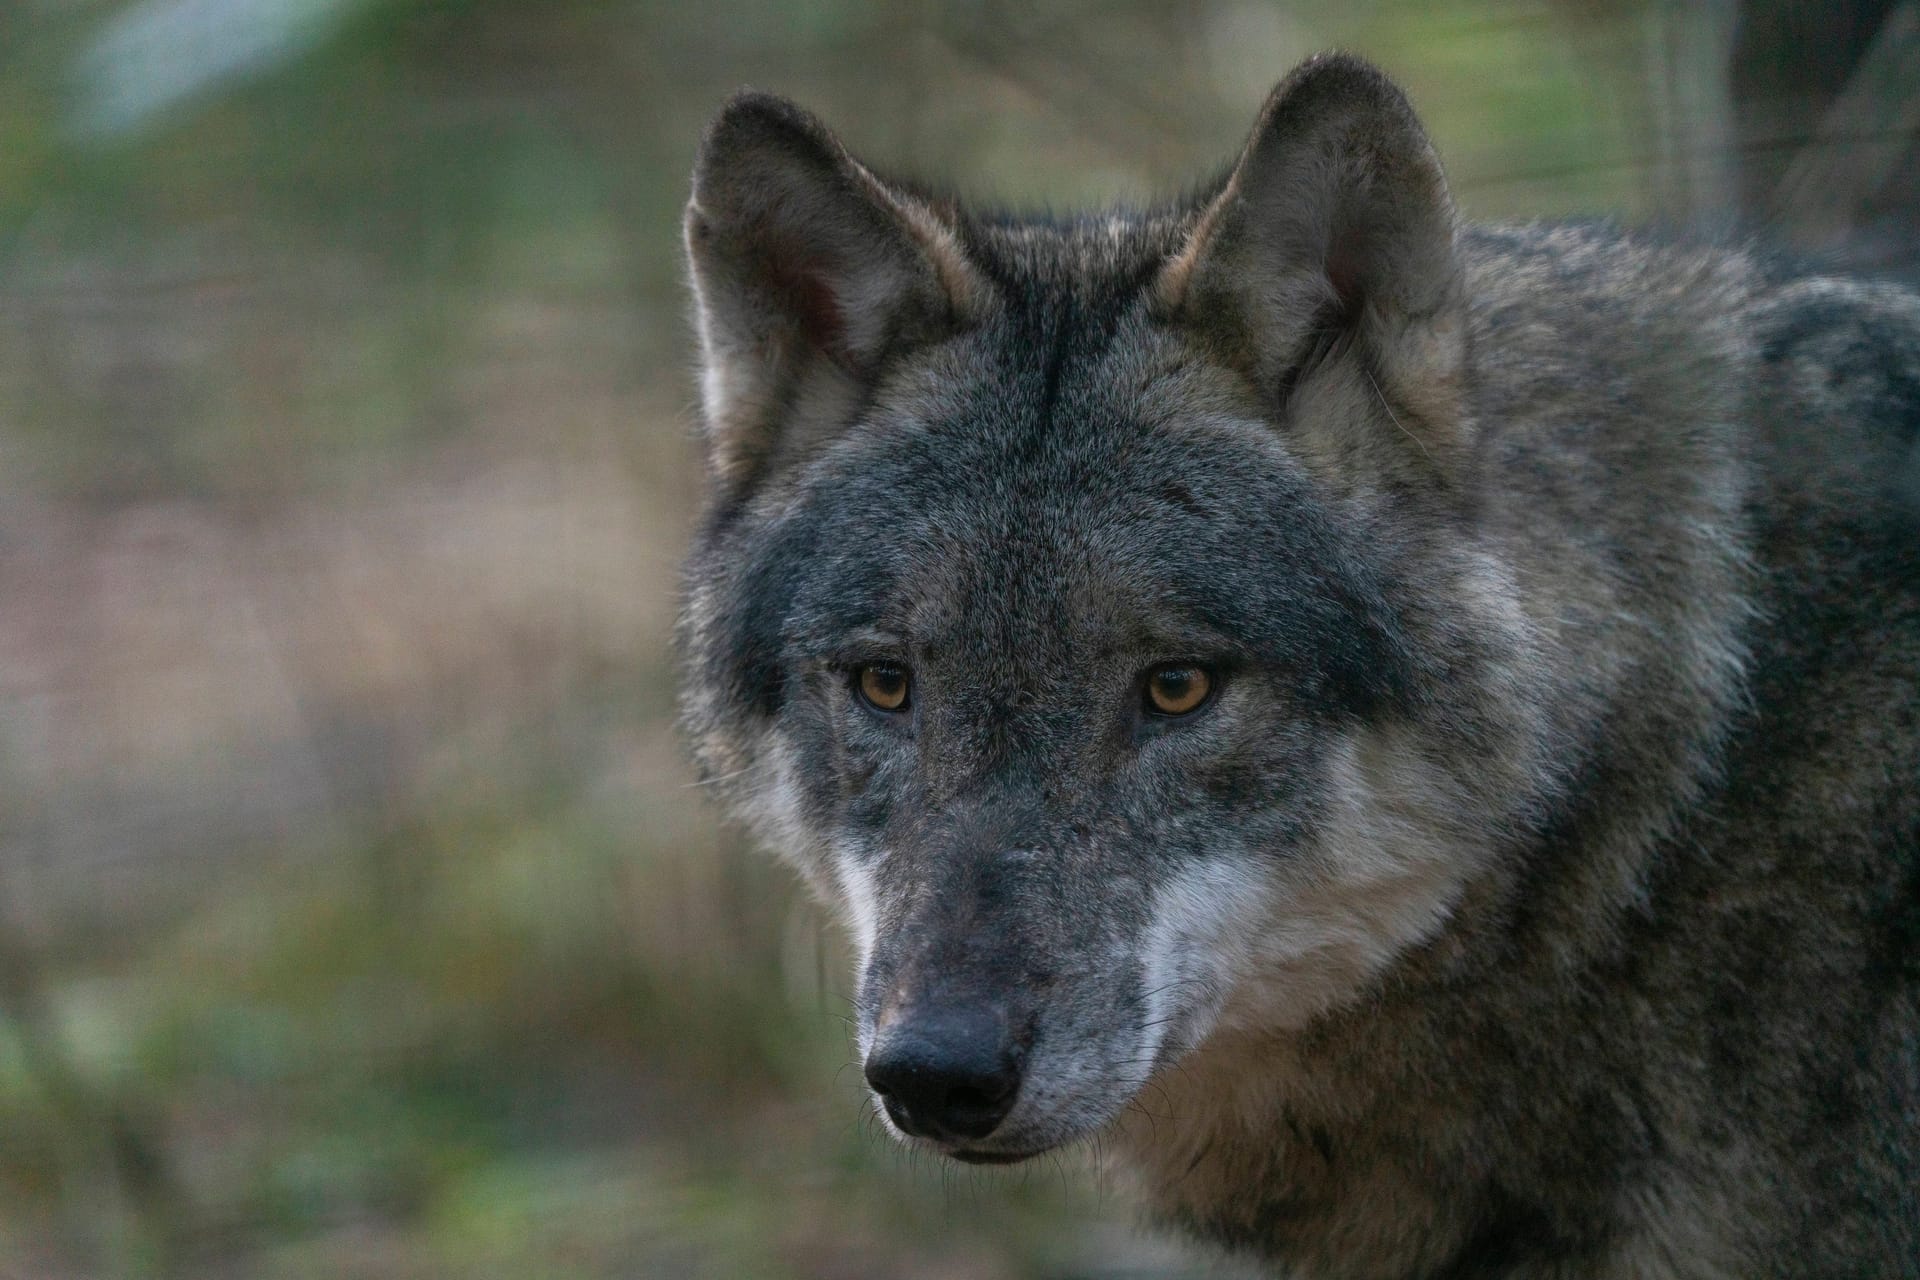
[1154,54,1467,461]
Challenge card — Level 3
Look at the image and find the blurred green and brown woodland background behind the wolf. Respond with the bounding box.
[0,0,1920,1280]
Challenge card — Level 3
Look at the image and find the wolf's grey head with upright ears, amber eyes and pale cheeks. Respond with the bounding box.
[682,58,1538,1161]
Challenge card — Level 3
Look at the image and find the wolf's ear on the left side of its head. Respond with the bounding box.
[685,92,979,478]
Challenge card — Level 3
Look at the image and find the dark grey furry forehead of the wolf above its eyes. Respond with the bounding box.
[802,339,1400,702]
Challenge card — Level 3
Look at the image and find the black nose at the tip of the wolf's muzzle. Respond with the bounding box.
[866,1009,1023,1140]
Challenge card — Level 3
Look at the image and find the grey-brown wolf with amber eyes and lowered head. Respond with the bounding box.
[680,56,1920,1278]
